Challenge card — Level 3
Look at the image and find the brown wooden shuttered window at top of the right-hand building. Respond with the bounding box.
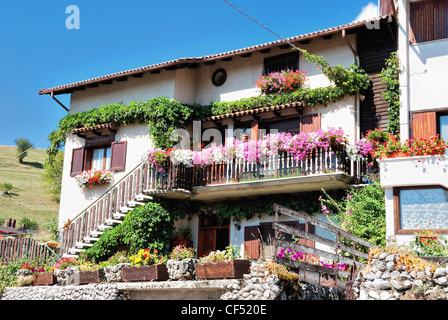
[410,0,448,43]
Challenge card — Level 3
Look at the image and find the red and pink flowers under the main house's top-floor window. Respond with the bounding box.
[255,70,306,93]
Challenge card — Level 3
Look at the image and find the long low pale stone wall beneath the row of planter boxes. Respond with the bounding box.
[0,261,345,300]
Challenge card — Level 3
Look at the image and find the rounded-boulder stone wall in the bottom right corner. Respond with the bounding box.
[354,251,448,300]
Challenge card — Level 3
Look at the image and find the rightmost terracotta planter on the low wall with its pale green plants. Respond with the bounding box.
[196,245,251,279]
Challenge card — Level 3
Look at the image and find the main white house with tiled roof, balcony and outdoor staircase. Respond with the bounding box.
[39,3,396,258]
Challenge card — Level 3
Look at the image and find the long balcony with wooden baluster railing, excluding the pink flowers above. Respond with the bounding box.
[144,147,370,201]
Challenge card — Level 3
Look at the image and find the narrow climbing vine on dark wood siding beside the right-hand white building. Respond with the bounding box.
[381,52,401,135]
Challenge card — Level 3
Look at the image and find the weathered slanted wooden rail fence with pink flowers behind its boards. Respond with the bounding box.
[273,204,375,292]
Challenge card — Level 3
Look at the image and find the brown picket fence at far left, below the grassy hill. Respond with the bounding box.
[0,238,53,261]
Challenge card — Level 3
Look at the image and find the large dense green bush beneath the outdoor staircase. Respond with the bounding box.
[84,202,174,262]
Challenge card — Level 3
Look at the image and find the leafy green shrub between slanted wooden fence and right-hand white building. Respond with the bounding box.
[321,181,386,247]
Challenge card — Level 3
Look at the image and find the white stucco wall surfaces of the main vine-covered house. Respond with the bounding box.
[60,34,358,233]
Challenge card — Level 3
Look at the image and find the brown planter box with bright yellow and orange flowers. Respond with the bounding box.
[121,249,169,282]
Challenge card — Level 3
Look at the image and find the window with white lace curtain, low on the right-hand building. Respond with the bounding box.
[394,186,448,233]
